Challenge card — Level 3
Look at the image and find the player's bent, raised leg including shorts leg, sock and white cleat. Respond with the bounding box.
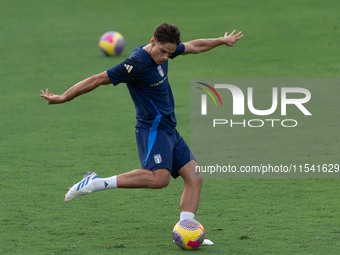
[65,129,172,202]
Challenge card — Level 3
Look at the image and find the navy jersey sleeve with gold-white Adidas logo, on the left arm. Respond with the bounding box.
[106,59,143,86]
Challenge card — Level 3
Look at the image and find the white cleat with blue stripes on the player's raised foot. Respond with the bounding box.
[64,172,100,202]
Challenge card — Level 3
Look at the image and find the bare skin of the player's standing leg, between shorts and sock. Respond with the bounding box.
[178,160,203,216]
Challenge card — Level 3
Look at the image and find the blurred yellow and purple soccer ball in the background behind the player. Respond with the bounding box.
[99,31,125,56]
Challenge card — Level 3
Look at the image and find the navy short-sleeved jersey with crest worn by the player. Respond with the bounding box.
[107,44,184,130]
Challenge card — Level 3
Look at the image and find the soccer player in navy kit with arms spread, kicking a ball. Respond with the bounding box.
[40,23,243,223]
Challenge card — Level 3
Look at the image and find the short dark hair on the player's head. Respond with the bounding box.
[153,22,181,45]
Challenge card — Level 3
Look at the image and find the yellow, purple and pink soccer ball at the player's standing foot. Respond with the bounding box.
[172,219,205,250]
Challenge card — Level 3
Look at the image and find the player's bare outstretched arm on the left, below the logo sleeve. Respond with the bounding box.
[40,71,111,104]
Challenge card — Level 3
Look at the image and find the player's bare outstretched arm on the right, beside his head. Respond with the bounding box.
[182,30,243,55]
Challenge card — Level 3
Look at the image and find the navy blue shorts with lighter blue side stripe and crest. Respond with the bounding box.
[136,128,195,179]
